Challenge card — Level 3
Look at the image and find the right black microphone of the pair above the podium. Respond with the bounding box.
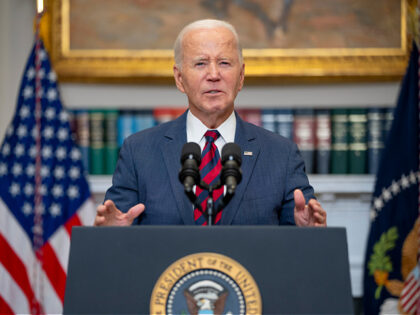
[220,142,242,195]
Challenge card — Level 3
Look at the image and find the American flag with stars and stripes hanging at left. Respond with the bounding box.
[0,35,95,314]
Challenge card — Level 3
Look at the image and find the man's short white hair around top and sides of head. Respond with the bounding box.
[174,19,243,69]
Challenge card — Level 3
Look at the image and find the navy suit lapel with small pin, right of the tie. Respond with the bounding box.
[221,113,260,225]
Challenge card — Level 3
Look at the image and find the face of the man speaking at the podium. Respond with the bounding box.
[174,27,244,127]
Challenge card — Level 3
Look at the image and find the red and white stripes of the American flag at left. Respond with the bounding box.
[0,198,94,314]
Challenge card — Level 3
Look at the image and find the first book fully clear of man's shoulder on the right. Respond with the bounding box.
[315,109,331,174]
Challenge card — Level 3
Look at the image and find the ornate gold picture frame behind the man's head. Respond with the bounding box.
[49,0,410,84]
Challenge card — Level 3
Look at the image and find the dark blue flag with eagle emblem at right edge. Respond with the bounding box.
[364,44,420,314]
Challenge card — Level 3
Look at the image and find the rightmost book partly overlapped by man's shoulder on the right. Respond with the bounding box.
[293,109,315,174]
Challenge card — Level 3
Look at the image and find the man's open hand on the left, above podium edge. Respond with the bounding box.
[94,200,145,226]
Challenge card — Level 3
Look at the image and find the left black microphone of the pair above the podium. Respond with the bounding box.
[179,142,201,194]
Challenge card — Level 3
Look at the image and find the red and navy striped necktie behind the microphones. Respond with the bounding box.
[194,130,223,225]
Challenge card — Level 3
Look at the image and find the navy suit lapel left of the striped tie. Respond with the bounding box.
[161,112,194,225]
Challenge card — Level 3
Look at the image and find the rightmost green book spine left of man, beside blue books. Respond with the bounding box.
[104,110,118,175]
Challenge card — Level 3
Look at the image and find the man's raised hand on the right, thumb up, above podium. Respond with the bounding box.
[294,189,327,226]
